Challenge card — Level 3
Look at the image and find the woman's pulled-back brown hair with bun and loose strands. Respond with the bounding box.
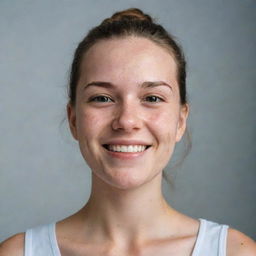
[69,8,191,185]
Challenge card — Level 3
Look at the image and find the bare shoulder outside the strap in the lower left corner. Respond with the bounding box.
[0,233,25,256]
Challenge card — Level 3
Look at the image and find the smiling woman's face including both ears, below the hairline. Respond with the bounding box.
[68,36,188,189]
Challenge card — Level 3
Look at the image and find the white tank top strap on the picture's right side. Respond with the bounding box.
[192,219,228,256]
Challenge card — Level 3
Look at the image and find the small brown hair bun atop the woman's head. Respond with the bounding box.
[105,8,153,22]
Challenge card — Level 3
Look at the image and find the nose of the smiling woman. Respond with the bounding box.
[112,102,142,133]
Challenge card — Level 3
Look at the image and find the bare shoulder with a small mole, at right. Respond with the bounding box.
[227,228,256,256]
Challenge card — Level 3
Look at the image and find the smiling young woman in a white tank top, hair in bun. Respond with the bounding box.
[0,9,256,256]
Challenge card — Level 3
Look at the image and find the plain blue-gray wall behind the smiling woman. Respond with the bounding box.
[0,0,256,240]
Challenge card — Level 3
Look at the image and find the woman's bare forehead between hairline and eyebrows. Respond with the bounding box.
[80,36,176,86]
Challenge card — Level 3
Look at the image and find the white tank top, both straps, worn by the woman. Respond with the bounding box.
[25,219,228,256]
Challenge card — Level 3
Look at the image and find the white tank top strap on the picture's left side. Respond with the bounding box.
[25,223,61,256]
